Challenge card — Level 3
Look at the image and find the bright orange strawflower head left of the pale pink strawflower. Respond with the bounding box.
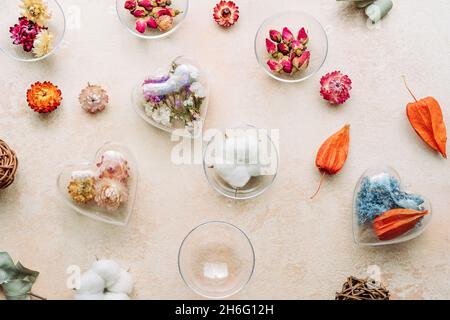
[27,81,62,113]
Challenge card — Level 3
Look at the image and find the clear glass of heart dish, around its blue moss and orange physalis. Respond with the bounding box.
[352,165,432,246]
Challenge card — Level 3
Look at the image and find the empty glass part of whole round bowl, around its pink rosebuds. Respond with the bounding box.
[255,11,328,82]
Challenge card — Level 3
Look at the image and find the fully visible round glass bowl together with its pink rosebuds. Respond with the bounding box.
[255,11,328,82]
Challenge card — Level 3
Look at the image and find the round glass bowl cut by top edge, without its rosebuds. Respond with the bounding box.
[116,0,189,39]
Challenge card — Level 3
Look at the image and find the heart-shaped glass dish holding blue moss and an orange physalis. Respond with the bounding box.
[352,166,432,246]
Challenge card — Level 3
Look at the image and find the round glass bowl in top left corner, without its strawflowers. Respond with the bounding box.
[0,0,66,62]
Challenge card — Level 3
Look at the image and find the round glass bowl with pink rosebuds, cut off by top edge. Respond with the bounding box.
[116,0,189,39]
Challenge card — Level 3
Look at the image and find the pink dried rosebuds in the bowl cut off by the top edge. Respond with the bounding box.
[125,0,181,33]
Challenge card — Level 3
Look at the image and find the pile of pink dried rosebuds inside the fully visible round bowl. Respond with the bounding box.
[266,27,311,74]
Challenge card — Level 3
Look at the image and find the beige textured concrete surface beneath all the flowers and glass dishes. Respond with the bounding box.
[0,0,450,299]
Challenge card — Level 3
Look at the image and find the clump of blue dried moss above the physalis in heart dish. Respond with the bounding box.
[356,173,425,224]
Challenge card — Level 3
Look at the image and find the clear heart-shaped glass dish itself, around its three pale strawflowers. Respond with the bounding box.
[57,142,138,226]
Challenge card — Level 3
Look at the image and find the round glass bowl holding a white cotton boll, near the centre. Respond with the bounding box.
[203,126,279,200]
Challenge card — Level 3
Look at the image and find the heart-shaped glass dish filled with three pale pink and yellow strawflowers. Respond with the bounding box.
[58,143,138,225]
